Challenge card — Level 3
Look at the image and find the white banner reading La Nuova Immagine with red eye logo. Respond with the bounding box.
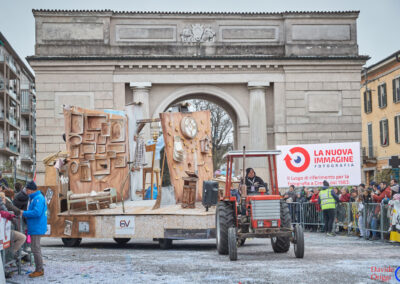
[277,142,361,187]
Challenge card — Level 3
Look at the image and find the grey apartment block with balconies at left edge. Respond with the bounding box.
[0,33,36,180]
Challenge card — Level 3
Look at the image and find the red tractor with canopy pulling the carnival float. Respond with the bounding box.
[215,148,304,260]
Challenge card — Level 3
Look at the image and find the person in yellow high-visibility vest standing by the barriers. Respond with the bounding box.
[318,180,339,237]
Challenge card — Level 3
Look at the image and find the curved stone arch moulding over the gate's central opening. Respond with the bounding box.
[152,85,249,147]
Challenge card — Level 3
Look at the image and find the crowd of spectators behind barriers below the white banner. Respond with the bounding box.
[283,179,400,240]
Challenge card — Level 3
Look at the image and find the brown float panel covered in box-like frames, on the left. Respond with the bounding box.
[64,107,129,200]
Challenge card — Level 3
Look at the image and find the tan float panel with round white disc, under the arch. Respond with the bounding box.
[160,111,213,203]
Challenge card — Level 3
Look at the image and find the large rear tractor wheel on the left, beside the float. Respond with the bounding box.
[215,201,236,254]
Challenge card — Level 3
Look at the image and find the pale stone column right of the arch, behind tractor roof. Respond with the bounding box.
[246,82,269,175]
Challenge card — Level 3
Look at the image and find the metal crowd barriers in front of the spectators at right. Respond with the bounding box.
[288,202,390,240]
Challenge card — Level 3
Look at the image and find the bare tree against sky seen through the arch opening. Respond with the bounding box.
[190,99,233,169]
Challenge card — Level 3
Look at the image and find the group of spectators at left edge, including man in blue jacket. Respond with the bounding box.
[0,171,47,278]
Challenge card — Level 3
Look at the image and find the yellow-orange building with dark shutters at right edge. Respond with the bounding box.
[361,51,400,182]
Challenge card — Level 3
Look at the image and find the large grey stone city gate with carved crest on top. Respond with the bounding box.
[29,10,367,183]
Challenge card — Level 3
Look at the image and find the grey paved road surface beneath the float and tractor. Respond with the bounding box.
[6,233,400,284]
